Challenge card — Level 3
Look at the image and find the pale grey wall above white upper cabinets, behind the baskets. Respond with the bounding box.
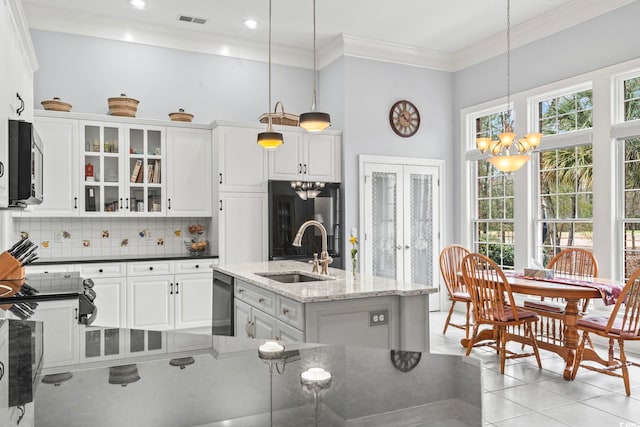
[31,30,313,123]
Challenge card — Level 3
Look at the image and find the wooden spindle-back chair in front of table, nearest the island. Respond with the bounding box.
[462,253,542,374]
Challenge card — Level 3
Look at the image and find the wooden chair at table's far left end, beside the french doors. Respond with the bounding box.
[440,245,471,338]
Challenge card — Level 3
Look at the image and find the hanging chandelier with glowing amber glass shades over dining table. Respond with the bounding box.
[476,0,542,173]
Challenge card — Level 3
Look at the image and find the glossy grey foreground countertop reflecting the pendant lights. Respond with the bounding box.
[0,320,482,427]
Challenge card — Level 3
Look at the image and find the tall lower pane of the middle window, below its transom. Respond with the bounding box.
[538,144,593,265]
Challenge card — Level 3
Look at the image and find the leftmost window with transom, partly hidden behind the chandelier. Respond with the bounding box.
[473,111,514,269]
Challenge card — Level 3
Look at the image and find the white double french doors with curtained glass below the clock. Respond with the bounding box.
[361,162,440,310]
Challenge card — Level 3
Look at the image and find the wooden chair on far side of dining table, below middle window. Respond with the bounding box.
[524,248,598,347]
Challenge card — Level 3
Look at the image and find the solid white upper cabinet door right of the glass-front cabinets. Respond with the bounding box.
[167,128,213,217]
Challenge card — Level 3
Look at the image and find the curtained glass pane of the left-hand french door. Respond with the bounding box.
[371,172,398,279]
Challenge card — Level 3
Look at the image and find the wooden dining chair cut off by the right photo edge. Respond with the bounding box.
[571,269,640,396]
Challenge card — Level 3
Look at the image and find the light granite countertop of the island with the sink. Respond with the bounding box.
[212,260,438,303]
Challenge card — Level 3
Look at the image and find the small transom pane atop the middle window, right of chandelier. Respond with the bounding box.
[538,89,593,135]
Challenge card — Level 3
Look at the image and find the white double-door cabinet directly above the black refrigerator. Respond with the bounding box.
[269,132,342,182]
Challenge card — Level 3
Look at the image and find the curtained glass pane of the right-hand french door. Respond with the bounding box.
[409,174,435,284]
